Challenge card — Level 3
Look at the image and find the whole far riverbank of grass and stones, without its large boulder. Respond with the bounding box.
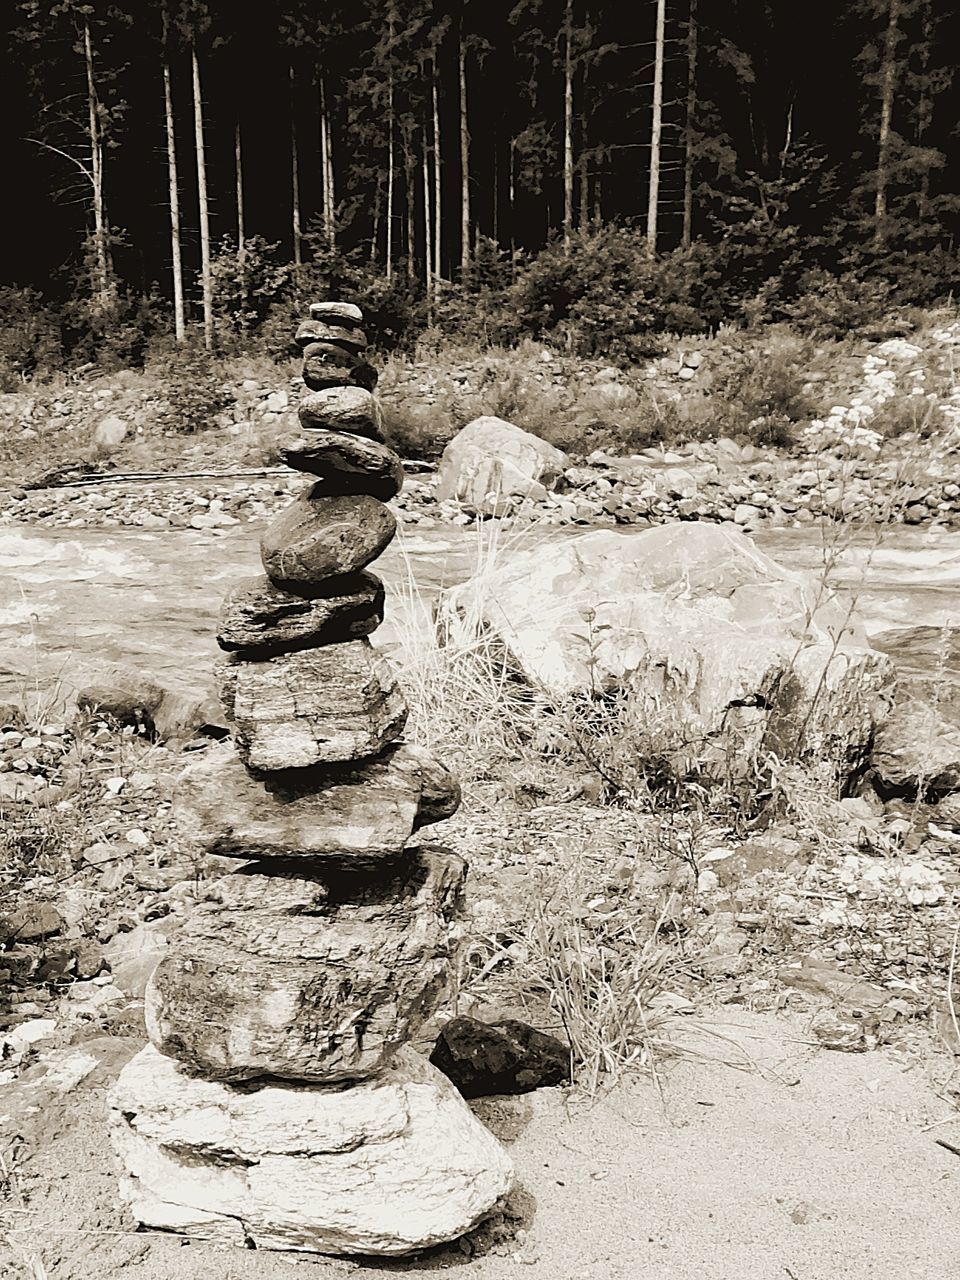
[0,311,960,529]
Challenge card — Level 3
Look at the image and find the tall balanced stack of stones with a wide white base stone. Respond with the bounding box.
[111,302,512,1254]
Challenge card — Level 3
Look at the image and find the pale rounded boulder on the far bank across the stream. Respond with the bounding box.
[436,417,570,516]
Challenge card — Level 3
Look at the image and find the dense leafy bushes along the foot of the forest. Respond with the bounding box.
[7,202,960,376]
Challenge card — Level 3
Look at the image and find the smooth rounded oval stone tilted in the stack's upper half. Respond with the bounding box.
[260,486,397,593]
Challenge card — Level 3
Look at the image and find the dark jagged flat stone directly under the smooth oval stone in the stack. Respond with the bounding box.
[216,572,384,657]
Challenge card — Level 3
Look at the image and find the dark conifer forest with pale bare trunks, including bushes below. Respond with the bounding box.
[0,0,960,381]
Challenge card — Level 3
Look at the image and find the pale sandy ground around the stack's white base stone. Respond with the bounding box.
[0,1011,960,1280]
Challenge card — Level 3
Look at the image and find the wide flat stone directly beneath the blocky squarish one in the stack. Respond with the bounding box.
[174,742,460,861]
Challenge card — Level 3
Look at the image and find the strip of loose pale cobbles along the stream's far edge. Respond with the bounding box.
[0,427,960,534]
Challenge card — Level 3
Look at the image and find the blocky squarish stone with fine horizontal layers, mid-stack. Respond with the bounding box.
[218,640,407,771]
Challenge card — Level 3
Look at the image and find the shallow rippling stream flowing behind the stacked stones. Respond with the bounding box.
[0,514,960,716]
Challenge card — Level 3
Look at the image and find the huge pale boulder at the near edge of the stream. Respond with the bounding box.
[443,522,893,778]
